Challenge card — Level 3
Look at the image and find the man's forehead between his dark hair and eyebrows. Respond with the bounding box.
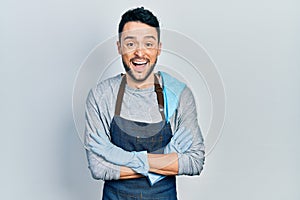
[121,22,158,39]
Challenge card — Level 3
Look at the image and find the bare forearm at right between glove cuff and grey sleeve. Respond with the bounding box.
[148,153,178,175]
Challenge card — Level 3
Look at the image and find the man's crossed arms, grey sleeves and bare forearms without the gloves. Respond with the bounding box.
[85,85,204,180]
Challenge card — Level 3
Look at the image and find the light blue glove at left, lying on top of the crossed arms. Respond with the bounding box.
[88,130,149,176]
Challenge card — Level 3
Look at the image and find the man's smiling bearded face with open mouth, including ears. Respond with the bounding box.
[117,22,161,82]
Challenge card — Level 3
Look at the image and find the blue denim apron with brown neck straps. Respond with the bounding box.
[102,75,177,200]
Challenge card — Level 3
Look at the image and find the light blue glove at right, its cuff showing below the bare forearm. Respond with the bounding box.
[148,127,193,186]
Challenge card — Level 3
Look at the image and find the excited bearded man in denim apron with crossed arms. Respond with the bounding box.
[85,7,204,200]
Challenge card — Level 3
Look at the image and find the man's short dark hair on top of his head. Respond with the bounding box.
[118,7,160,41]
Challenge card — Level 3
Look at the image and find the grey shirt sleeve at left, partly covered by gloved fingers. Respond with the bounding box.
[84,89,120,180]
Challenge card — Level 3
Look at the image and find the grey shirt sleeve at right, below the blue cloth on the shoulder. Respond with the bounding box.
[173,87,205,175]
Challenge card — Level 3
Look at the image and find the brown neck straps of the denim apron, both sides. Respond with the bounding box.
[115,75,165,120]
